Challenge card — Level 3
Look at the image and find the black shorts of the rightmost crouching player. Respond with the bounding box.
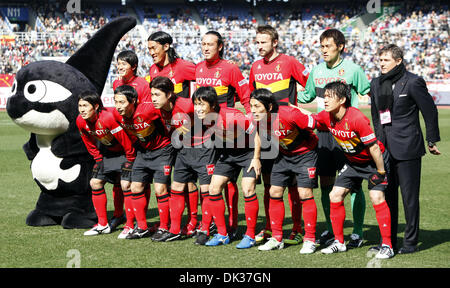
[334,151,389,192]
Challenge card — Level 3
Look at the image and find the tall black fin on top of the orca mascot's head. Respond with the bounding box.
[66,16,136,95]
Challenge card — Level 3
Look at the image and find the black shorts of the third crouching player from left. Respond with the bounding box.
[173,147,218,185]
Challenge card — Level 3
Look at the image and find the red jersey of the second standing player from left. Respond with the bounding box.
[146,58,195,98]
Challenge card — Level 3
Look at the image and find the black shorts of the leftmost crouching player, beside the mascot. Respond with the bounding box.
[95,151,131,184]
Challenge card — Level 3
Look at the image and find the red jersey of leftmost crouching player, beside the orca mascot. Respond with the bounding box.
[76,109,136,161]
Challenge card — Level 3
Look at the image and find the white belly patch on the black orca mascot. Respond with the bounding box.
[31,135,81,190]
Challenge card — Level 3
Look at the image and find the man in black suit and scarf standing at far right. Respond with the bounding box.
[370,44,441,254]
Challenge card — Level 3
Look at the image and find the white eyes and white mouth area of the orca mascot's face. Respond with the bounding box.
[10,80,72,136]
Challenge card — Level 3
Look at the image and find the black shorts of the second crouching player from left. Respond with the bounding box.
[131,144,176,185]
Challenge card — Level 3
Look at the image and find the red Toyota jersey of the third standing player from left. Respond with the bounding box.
[195,58,250,114]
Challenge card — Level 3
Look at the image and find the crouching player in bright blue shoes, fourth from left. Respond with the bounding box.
[192,86,261,248]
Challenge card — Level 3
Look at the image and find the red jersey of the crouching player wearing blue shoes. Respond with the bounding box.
[210,107,256,149]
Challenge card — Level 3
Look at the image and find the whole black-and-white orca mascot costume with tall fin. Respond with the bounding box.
[6,17,136,228]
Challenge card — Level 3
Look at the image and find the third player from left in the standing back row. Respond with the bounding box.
[195,31,250,238]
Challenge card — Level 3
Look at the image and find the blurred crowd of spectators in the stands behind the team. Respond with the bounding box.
[0,1,450,80]
